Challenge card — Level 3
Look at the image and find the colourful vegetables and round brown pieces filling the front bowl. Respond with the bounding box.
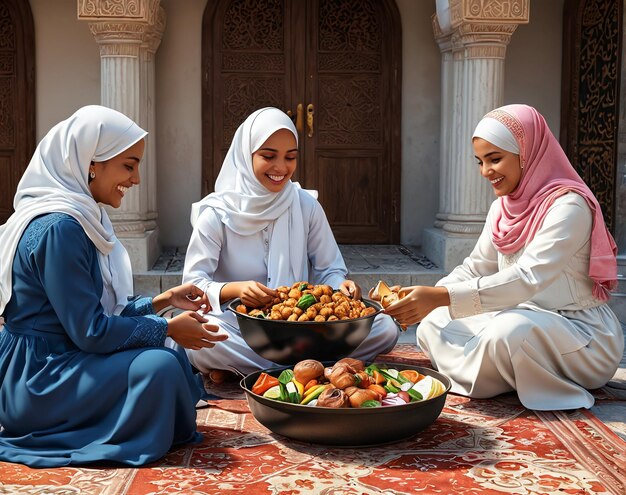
[252,358,446,409]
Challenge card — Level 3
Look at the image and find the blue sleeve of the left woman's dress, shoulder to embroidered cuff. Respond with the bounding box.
[22,214,168,354]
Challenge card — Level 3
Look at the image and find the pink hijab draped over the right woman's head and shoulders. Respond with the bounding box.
[472,105,617,301]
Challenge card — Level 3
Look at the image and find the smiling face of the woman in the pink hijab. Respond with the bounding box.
[472,137,522,196]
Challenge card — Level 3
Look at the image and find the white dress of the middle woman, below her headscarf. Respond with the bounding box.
[183,189,399,373]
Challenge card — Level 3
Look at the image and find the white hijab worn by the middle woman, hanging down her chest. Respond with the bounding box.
[191,107,308,287]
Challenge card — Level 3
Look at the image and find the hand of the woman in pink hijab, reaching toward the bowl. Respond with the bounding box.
[385,285,450,327]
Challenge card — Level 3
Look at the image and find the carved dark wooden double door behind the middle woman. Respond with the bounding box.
[203,0,401,244]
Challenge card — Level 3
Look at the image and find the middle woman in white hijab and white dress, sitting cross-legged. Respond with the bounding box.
[183,107,398,381]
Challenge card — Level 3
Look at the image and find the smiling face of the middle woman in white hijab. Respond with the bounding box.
[252,129,298,192]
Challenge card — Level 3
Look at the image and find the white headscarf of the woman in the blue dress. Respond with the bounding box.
[0,105,148,315]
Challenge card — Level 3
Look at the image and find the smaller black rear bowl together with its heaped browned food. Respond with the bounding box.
[228,282,382,365]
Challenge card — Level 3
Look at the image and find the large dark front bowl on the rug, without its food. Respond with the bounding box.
[240,364,450,447]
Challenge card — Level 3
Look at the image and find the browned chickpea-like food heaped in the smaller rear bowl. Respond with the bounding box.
[235,282,376,322]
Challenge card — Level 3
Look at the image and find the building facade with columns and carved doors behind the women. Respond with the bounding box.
[0,0,626,290]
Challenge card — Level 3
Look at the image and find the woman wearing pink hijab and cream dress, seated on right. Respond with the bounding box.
[387,105,624,410]
